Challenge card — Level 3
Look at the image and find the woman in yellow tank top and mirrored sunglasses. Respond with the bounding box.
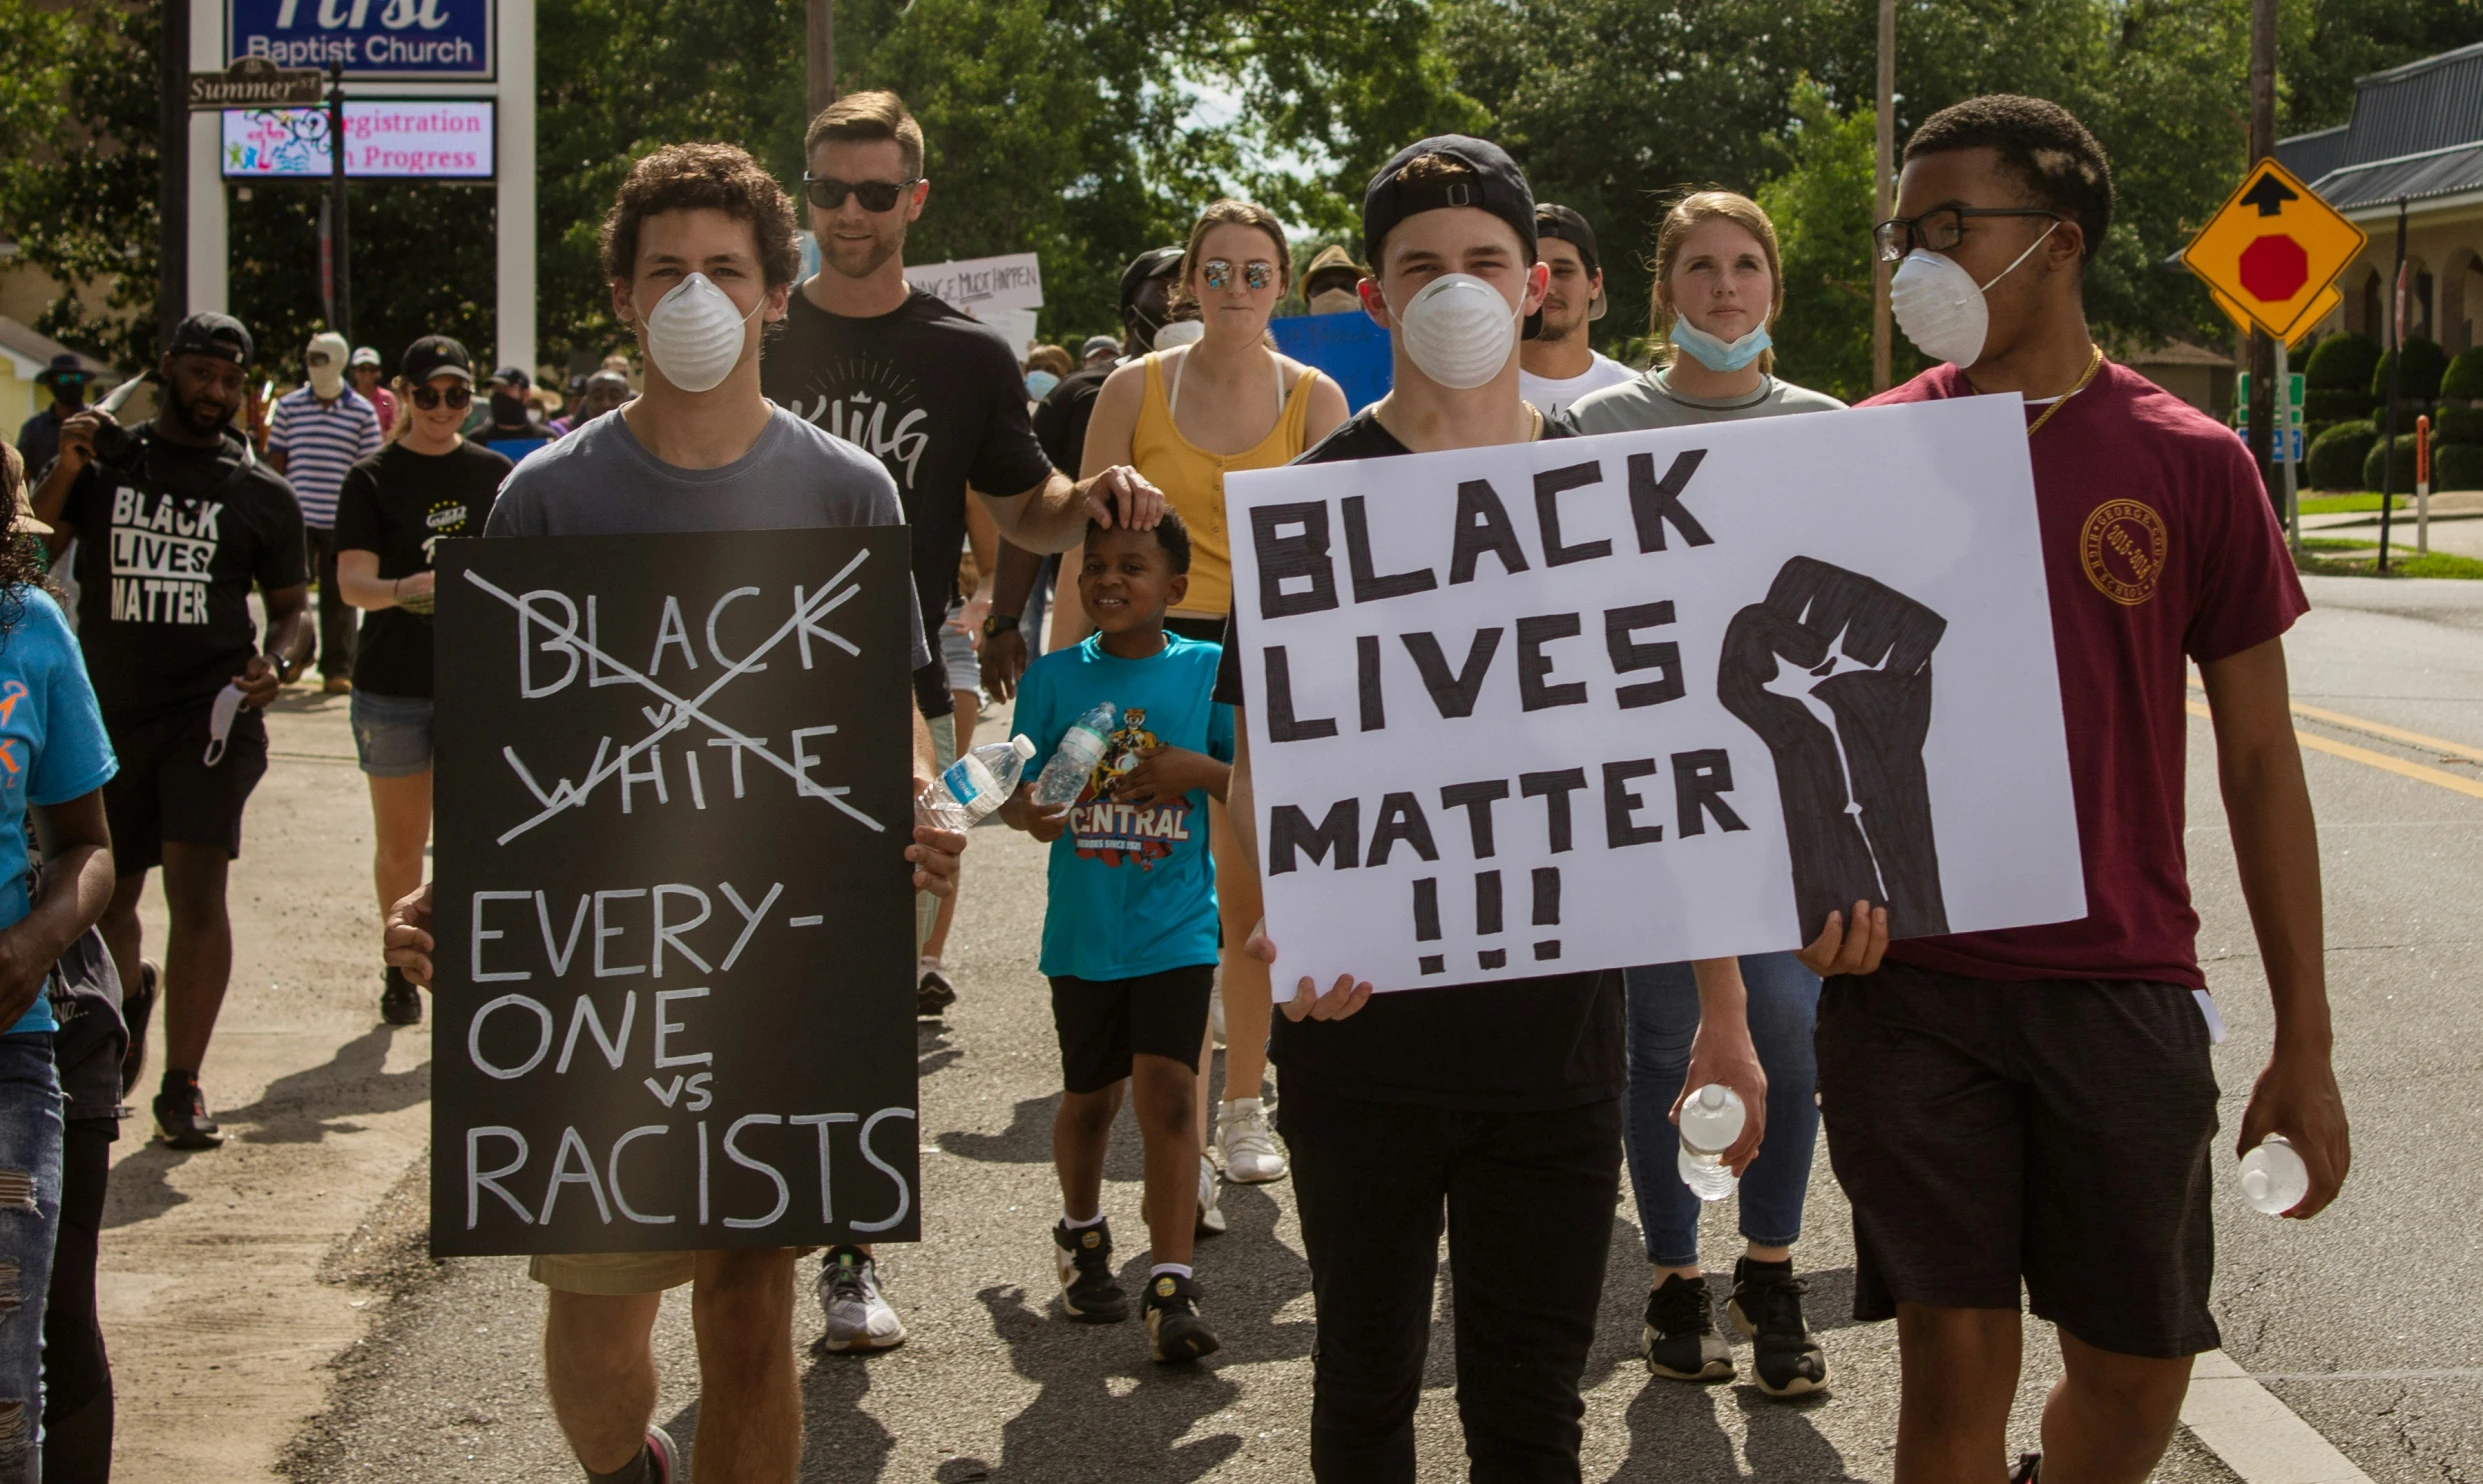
[1053,201,1346,1206]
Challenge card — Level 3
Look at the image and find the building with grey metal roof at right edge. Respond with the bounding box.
[2277,42,2483,355]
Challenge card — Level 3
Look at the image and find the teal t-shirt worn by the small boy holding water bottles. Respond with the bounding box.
[1016,633,1234,980]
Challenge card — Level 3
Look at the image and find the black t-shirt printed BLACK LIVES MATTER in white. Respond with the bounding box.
[60,432,310,722]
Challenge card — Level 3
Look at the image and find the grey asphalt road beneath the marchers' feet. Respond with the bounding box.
[198,578,2483,1484]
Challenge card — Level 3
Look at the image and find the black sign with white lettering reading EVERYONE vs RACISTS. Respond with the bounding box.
[432,526,919,1256]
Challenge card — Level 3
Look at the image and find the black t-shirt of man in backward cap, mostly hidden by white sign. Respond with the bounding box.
[1217,409,1629,1109]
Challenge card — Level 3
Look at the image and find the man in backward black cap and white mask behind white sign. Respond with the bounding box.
[1217,134,1768,1484]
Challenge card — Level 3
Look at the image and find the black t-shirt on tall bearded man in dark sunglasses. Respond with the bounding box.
[760,283,1053,717]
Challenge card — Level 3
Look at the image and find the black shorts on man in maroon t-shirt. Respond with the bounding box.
[1818,963,2222,1357]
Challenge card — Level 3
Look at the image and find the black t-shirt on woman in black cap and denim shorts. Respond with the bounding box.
[335,442,514,697]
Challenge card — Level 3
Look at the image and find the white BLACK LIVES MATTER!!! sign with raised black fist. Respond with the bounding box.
[1224,397,2086,990]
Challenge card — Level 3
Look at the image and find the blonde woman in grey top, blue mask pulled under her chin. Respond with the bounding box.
[1569,191,1845,1397]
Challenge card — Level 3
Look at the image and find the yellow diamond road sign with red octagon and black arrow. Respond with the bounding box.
[2180,159,2369,335]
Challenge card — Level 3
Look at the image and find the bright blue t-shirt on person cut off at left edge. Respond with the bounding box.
[0,588,119,1035]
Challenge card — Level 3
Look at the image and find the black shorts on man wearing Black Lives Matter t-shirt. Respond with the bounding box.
[104,702,268,876]
